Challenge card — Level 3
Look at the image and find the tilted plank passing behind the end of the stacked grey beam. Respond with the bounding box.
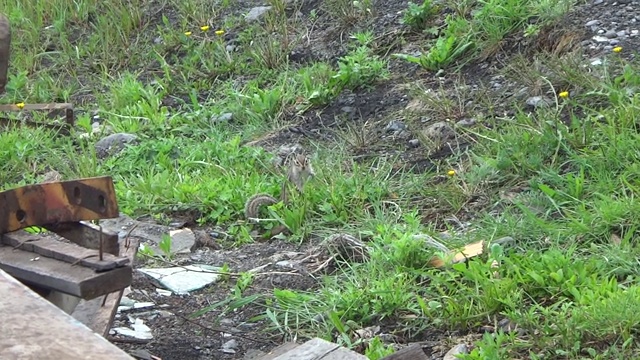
[72,239,138,337]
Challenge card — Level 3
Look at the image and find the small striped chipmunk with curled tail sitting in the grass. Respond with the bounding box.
[244,154,315,236]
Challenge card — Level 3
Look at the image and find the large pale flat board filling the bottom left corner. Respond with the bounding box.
[0,270,133,360]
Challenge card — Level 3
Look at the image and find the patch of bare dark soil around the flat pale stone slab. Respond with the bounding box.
[110,236,318,360]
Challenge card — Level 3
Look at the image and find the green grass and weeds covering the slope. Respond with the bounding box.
[0,0,640,359]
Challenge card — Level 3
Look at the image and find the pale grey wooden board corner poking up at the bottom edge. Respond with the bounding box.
[259,338,367,360]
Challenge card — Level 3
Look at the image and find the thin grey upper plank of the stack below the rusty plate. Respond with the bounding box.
[0,230,129,271]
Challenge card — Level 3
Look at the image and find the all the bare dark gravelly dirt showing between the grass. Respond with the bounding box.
[102,0,639,360]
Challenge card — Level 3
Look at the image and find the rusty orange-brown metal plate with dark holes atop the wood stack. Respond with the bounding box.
[0,176,119,234]
